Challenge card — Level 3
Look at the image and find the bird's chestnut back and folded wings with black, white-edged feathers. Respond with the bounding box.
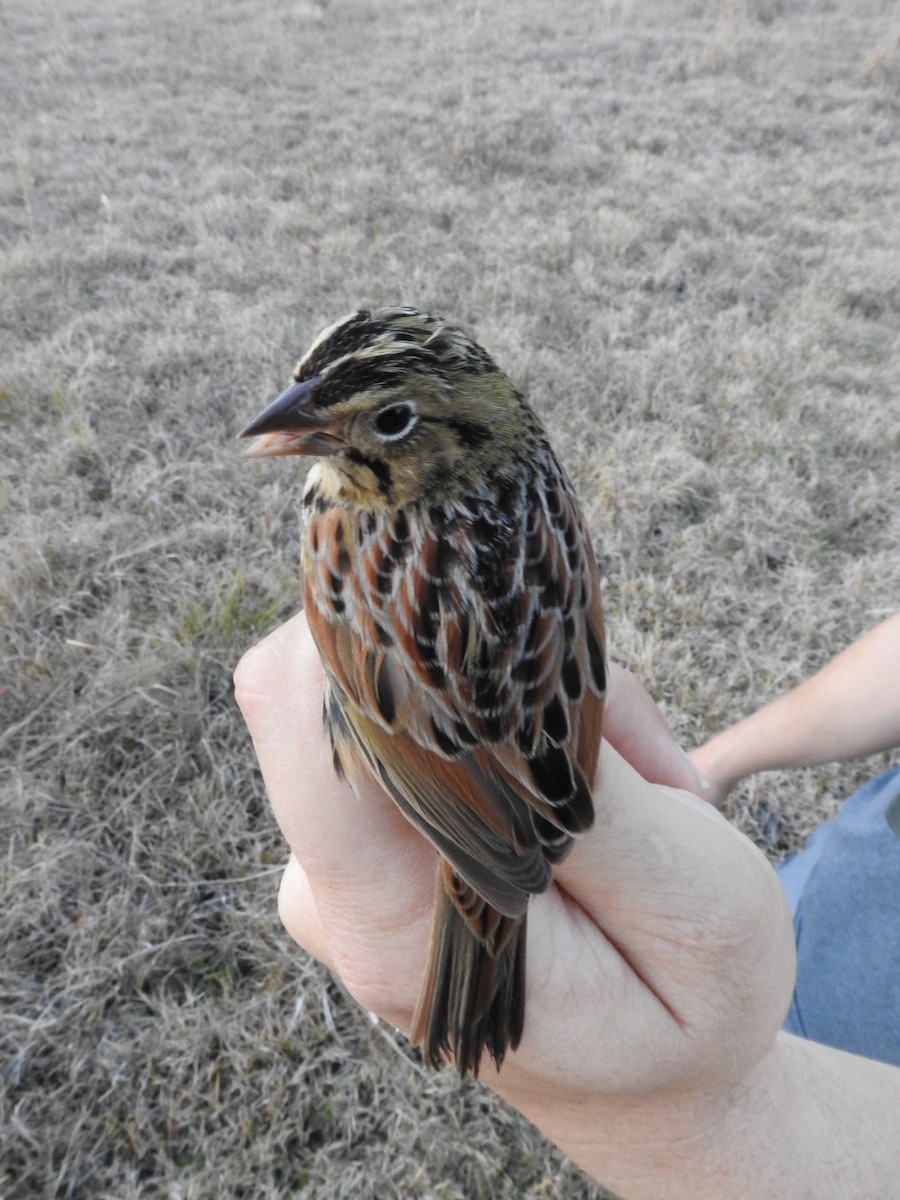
[305,455,605,914]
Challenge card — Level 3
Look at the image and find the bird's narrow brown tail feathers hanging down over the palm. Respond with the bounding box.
[413,859,526,1078]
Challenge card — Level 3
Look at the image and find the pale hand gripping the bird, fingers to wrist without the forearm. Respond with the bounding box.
[236,616,793,1094]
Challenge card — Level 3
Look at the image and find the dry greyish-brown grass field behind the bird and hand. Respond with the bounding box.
[0,0,900,1200]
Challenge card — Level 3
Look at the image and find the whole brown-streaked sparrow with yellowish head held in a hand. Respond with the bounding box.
[240,307,607,1078]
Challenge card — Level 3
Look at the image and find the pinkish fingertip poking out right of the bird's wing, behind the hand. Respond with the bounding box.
[604,662,710,799]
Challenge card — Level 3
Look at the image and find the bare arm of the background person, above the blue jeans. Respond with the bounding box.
[690,613,900,799]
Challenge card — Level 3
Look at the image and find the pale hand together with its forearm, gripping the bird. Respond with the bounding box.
[235,616,900,1200]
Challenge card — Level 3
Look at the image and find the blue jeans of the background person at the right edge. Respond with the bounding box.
[778,767,900,1066]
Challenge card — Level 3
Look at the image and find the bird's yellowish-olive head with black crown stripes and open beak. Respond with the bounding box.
[241,308,542,508]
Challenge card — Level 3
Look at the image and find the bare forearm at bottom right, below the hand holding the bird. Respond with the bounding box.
[499,1033,900,1200]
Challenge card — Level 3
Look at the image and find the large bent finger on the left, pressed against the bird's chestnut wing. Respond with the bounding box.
[235,614,436,1025]
